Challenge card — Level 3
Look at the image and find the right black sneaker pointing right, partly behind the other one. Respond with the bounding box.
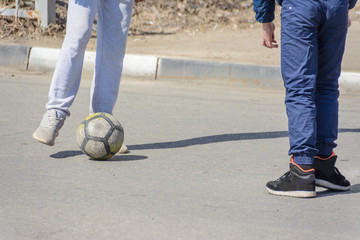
[314,152,350,191]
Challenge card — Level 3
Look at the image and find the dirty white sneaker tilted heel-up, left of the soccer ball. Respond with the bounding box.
[32,109,65,146]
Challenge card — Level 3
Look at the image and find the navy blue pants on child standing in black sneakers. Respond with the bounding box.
[281,0,348,164]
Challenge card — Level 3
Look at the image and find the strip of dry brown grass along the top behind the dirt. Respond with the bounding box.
[0,0,253,40]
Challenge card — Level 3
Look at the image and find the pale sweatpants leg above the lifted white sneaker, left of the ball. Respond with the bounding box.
[46,0,99,115]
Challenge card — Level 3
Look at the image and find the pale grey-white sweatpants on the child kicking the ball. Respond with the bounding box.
[46,0,134,116]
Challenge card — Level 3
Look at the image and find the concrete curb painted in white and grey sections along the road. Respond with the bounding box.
[0,45,360,91]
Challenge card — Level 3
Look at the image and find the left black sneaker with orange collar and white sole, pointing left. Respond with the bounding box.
[266,160,316,198]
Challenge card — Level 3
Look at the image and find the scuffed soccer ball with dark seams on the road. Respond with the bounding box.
[76,112,124,160]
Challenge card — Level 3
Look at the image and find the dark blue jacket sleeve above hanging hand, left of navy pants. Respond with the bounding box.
[254,0,276,23]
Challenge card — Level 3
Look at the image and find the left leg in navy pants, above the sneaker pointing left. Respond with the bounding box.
[281,0,323,165]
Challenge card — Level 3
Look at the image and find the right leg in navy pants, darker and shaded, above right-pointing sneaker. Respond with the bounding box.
[315,0,348,156]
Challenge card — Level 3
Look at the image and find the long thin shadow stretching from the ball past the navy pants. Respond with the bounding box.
[127,128,360,150]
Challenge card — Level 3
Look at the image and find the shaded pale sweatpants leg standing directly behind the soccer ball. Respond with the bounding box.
[90,0,134,114]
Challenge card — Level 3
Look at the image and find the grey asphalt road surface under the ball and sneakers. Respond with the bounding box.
[0,71,360,240]
